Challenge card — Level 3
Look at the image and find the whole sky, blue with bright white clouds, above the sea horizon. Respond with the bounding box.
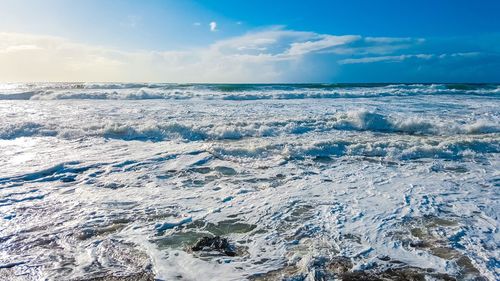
[0,0,500,82]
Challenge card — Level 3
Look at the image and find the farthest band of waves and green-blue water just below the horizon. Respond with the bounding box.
[0,83,500,101]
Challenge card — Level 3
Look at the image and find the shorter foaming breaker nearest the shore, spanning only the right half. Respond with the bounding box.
[207,137,500,161]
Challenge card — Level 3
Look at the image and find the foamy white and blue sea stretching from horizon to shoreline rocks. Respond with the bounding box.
[0,83,500,280]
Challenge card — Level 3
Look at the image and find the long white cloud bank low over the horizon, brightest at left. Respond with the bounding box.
[0,29,496,83]
